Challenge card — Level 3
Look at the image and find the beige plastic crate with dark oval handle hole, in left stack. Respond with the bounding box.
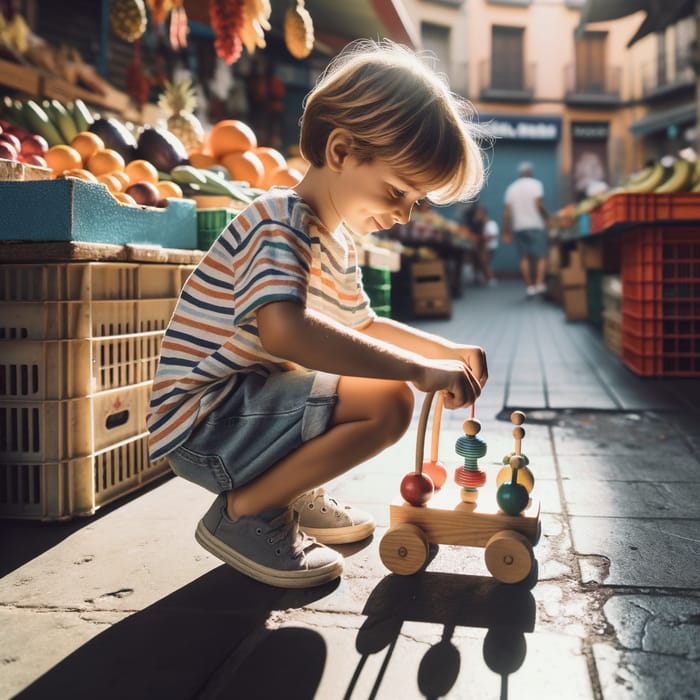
[0,382,152,464]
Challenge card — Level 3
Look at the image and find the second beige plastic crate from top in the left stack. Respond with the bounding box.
[0,297,177,340]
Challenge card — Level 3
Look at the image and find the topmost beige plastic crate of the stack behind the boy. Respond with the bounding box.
[0,262,195,301]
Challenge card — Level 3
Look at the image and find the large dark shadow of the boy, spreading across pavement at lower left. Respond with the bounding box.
[15,566,338,700]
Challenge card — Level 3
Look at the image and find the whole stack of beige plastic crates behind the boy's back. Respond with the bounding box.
[0,262,194,520]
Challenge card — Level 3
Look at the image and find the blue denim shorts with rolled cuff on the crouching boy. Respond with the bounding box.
[168,369,338,494]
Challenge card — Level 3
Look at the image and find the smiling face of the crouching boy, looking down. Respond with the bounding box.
[331,156,426,235]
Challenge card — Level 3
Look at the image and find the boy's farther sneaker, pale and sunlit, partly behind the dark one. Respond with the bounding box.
[292,488,377,544]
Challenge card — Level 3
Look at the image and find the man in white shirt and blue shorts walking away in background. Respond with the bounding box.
[502,163,549,296]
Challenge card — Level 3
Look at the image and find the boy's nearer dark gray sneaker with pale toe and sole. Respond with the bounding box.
[195,494,343,588]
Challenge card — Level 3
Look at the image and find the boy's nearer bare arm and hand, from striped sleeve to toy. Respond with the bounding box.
[257,301,481,408]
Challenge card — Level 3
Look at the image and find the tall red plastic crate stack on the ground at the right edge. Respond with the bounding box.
[622,224,700,377]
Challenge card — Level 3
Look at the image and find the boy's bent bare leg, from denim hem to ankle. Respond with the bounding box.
[227,377,413,520]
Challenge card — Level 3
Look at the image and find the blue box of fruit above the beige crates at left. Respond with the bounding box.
[0,178,197,248]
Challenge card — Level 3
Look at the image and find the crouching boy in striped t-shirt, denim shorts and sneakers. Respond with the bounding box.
[148,42,487,588]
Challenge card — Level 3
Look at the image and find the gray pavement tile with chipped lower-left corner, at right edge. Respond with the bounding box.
[570,516,700,589]
